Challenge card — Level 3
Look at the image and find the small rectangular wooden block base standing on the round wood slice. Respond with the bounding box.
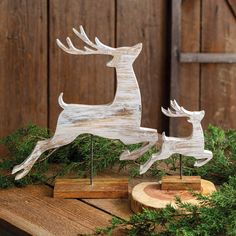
[161,175,201,191]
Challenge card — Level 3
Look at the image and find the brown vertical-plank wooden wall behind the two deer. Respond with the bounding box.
[0,0,236,140]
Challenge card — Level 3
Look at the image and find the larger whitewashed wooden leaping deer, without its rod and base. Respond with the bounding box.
[12,26,158,179]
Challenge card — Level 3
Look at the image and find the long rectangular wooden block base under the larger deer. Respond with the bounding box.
[53,178,128,199]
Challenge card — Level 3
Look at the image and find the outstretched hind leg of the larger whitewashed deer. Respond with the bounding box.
[12,136,77,180]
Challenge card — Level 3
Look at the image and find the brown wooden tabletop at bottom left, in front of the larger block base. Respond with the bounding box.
[0,186,111,236]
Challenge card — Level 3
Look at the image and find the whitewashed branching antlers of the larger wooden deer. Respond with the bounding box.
[56,26,115,55]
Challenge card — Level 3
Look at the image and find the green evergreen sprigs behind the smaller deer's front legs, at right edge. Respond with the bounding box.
[184,125,236,184]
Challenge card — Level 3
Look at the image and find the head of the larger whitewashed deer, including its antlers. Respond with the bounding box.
[57,26,142,67]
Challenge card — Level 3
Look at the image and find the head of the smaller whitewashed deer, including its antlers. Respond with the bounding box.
[161,100,205,123]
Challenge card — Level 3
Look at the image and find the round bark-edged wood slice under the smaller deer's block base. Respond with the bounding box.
[131,179,216,212]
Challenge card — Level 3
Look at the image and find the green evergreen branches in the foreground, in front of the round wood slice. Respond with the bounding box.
[97,177,236,236]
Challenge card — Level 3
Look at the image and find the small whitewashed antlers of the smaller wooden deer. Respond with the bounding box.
[161,100,192,117]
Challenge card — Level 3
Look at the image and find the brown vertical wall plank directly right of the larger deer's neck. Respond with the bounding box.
[116,0,169,132]
